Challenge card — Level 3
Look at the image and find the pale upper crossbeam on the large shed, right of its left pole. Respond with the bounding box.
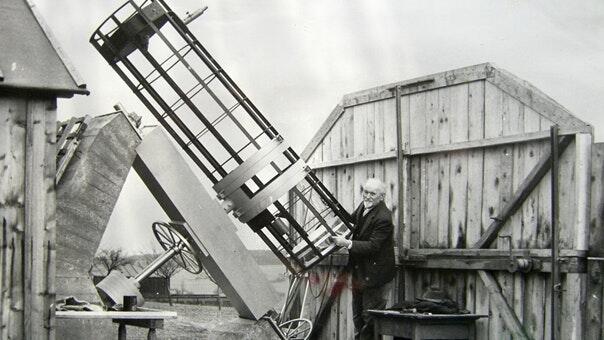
[404,129,585,156]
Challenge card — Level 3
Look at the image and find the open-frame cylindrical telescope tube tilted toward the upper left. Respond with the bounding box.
[90,0,351,274]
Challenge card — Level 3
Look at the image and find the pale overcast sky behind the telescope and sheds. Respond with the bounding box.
[34,0,604,253]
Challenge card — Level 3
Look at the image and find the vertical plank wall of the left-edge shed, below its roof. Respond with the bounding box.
[0,96,56,339]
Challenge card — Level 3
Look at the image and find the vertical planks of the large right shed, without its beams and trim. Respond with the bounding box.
[300,80,583,339]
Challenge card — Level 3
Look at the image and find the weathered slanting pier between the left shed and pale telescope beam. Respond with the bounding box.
[57,113,140,302]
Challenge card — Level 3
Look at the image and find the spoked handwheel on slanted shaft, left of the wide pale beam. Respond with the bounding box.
[152,222,203,274]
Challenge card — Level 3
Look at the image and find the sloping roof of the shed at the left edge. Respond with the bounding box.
[0,0,89,97]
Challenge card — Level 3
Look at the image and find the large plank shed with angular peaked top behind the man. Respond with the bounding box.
[302,64,604,340]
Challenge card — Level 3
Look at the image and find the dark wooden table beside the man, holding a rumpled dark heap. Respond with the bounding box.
[367,309,488,340]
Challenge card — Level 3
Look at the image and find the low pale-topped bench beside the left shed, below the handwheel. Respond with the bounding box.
[55,307,176,340]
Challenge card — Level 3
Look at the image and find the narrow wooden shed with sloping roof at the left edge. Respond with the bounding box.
[0,0,88,339]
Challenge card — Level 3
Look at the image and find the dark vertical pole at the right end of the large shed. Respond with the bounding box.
[550,125,561,340]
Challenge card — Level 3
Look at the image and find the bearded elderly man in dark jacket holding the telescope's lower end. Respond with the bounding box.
[332,178,395,339]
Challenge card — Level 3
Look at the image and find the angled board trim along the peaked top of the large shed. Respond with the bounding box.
[301,63,592,160]
